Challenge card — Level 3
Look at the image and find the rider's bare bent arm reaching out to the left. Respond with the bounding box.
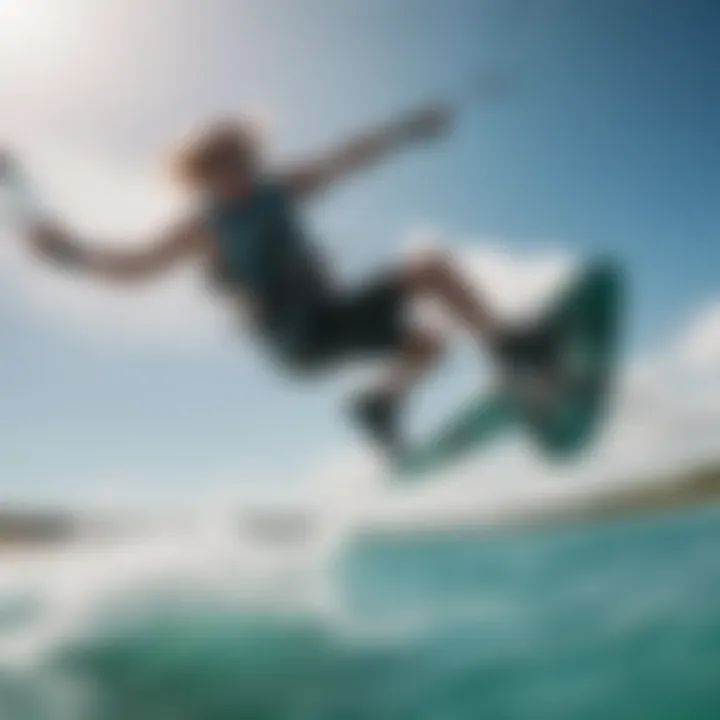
[30,214,205,282]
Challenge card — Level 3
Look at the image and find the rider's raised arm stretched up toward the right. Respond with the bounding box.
[287,105,452,196]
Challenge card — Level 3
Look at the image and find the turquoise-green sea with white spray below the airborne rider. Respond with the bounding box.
[0,508,720,720]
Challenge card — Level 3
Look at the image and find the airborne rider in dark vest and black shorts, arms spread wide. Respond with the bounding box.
[5,105,544,451]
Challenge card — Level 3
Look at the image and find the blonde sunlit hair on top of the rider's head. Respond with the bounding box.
[170,118,262,185]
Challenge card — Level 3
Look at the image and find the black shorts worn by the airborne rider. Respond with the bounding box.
[262,274,408,370]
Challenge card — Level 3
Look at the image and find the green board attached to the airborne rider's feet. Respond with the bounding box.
[394,263,622,479]
